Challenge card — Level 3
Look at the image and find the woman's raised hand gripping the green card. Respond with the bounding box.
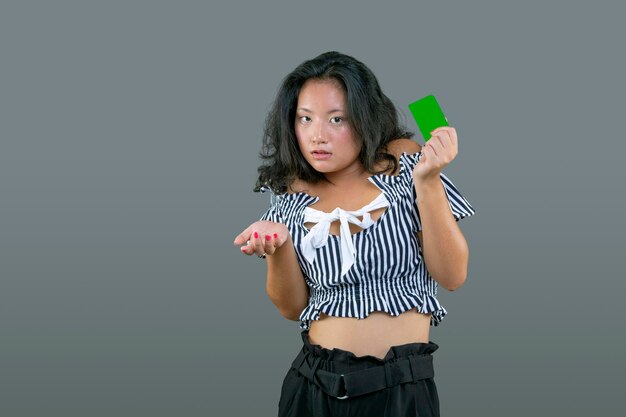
[413,126,458,181]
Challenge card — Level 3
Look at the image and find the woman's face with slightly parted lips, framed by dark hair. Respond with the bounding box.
[295,79,361,173]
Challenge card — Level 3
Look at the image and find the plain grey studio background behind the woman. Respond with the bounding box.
[0,1,626,417]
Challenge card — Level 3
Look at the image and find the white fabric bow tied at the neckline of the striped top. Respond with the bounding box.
[300,193,389,276]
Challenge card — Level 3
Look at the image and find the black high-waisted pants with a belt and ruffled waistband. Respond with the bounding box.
[278,330,439,417]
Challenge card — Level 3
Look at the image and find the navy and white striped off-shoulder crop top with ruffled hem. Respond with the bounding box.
[261,152,475,330]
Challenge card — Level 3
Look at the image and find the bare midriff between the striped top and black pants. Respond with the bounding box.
[309,309,431,359]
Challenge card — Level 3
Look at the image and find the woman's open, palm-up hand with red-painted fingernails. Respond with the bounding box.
[233,220,291,256]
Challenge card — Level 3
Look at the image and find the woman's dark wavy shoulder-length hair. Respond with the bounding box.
[254,51,414,194]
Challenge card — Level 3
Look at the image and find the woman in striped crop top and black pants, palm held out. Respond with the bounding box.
[234,52,475,417]
